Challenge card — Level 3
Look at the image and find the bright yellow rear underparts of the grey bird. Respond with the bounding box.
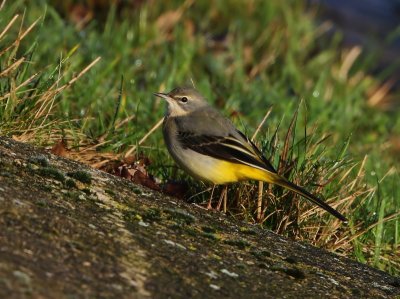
[208,161,275,184]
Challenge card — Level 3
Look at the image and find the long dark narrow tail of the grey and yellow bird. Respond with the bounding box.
[266,173,348,222]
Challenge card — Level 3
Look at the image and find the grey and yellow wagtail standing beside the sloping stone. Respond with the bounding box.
[154,88,347,222]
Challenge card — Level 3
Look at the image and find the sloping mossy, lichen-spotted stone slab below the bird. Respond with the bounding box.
[0,138,400,298]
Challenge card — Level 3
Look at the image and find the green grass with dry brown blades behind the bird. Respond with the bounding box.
[0,1,400,273]
